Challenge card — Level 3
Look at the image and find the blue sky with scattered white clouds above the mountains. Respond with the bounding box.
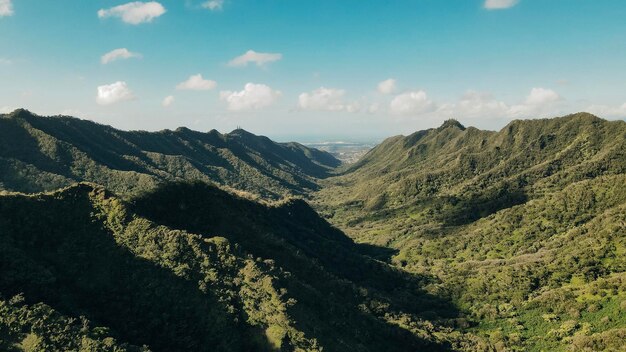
[0,0,626,141]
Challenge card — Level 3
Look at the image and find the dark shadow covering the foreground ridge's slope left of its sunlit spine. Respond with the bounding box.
[0,186,271,351]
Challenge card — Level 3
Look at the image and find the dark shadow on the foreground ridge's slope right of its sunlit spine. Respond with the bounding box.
[133,183,460,351]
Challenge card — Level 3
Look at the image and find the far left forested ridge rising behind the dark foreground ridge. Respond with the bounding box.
[0,110,340,198]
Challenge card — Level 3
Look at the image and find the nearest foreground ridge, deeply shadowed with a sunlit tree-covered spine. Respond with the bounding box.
[0,183,480,351]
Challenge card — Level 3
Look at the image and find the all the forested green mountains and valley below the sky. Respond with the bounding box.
[0,110,626,351]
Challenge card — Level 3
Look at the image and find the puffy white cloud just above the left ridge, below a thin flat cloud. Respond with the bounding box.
[220,83,282,111]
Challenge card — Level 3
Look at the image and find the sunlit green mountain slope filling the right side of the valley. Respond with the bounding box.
[315,113,626,351]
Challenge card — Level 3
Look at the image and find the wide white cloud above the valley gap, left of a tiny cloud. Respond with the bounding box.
[298,87,361,112]
